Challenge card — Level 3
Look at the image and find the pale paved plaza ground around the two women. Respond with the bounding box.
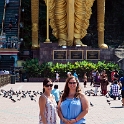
[0,82,124,124]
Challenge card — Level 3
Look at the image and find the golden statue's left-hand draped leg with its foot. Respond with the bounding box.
[55,0,67,46]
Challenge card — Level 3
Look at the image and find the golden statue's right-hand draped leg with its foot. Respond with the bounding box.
[74,0,86,46]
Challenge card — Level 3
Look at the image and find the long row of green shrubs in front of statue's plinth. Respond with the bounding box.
[23,59,119,78]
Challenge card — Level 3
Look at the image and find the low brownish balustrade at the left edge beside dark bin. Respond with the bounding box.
[0,74,11,87]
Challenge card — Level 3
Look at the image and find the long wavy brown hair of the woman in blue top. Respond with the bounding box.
[62,76,81,101]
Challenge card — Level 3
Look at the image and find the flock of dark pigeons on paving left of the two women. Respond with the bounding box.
[0,88,42,102]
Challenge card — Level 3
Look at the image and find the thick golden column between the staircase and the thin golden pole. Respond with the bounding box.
[31,0,39,48]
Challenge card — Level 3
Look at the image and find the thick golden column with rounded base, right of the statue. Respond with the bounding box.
[97,0,108,49]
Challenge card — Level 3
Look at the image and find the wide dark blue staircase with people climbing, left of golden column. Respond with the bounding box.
[4,0,20,38]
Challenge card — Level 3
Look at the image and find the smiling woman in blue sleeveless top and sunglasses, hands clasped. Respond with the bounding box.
[58,76,89,124]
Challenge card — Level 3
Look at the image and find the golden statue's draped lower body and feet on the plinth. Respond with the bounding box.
[45,0,107,48]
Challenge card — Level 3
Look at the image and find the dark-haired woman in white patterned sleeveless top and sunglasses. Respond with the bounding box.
[39,78,57,124]
